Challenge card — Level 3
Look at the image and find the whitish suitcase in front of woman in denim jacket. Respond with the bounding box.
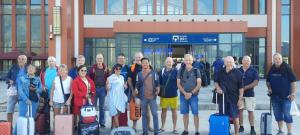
[17,105,35,135]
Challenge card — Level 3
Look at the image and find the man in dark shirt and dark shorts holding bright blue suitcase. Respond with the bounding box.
[215,56,244,135]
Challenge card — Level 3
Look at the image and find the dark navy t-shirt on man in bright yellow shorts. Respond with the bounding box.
[159,68,178,98]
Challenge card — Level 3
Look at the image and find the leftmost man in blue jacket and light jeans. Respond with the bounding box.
[6,55,27,122]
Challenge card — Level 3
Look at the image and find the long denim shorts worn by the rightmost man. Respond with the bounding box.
[271,96,293,123]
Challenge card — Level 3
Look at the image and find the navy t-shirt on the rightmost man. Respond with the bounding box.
[267,63,296,98]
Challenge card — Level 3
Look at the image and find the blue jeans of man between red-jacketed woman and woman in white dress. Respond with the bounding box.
[94,87,106,125]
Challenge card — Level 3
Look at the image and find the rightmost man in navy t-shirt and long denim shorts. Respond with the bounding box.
[266,53,296,135]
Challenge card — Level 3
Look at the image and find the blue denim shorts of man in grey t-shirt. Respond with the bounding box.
[180,94,199,115]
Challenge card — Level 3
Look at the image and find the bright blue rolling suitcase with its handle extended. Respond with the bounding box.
[209,93,229,135]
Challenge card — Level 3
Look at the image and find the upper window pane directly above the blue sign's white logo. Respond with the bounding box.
[168,0,183,15]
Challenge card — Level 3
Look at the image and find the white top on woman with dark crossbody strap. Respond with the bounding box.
[53,76,72,103]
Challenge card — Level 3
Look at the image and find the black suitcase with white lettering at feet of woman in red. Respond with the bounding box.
[78,121,99,135]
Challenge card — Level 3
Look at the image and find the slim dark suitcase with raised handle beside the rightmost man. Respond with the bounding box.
[260,96,272,135]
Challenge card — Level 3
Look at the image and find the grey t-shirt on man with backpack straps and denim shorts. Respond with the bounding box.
[177,68,201,92]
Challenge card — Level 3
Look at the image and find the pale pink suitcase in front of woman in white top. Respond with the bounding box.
[54,106,74,135]
